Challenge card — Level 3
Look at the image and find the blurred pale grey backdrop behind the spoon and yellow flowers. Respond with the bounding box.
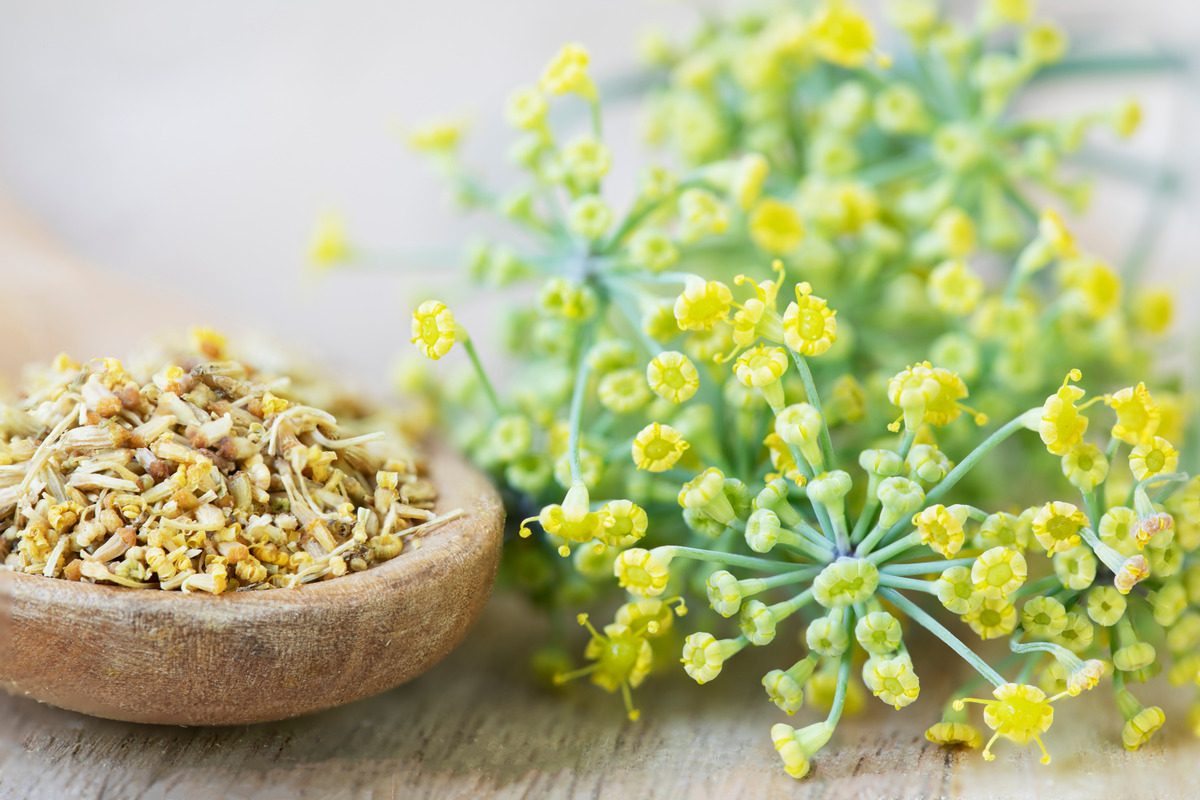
[0,0,1200,389]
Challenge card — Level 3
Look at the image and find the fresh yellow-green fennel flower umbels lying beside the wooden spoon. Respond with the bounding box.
[313,0,1200,777]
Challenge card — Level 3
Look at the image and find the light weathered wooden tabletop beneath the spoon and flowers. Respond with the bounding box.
[0,596,1200,800]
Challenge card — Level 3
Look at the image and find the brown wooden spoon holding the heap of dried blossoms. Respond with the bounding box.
[0,191,504,726]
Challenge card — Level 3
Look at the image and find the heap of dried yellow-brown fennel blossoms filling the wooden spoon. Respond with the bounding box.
[0,351,456,594]
